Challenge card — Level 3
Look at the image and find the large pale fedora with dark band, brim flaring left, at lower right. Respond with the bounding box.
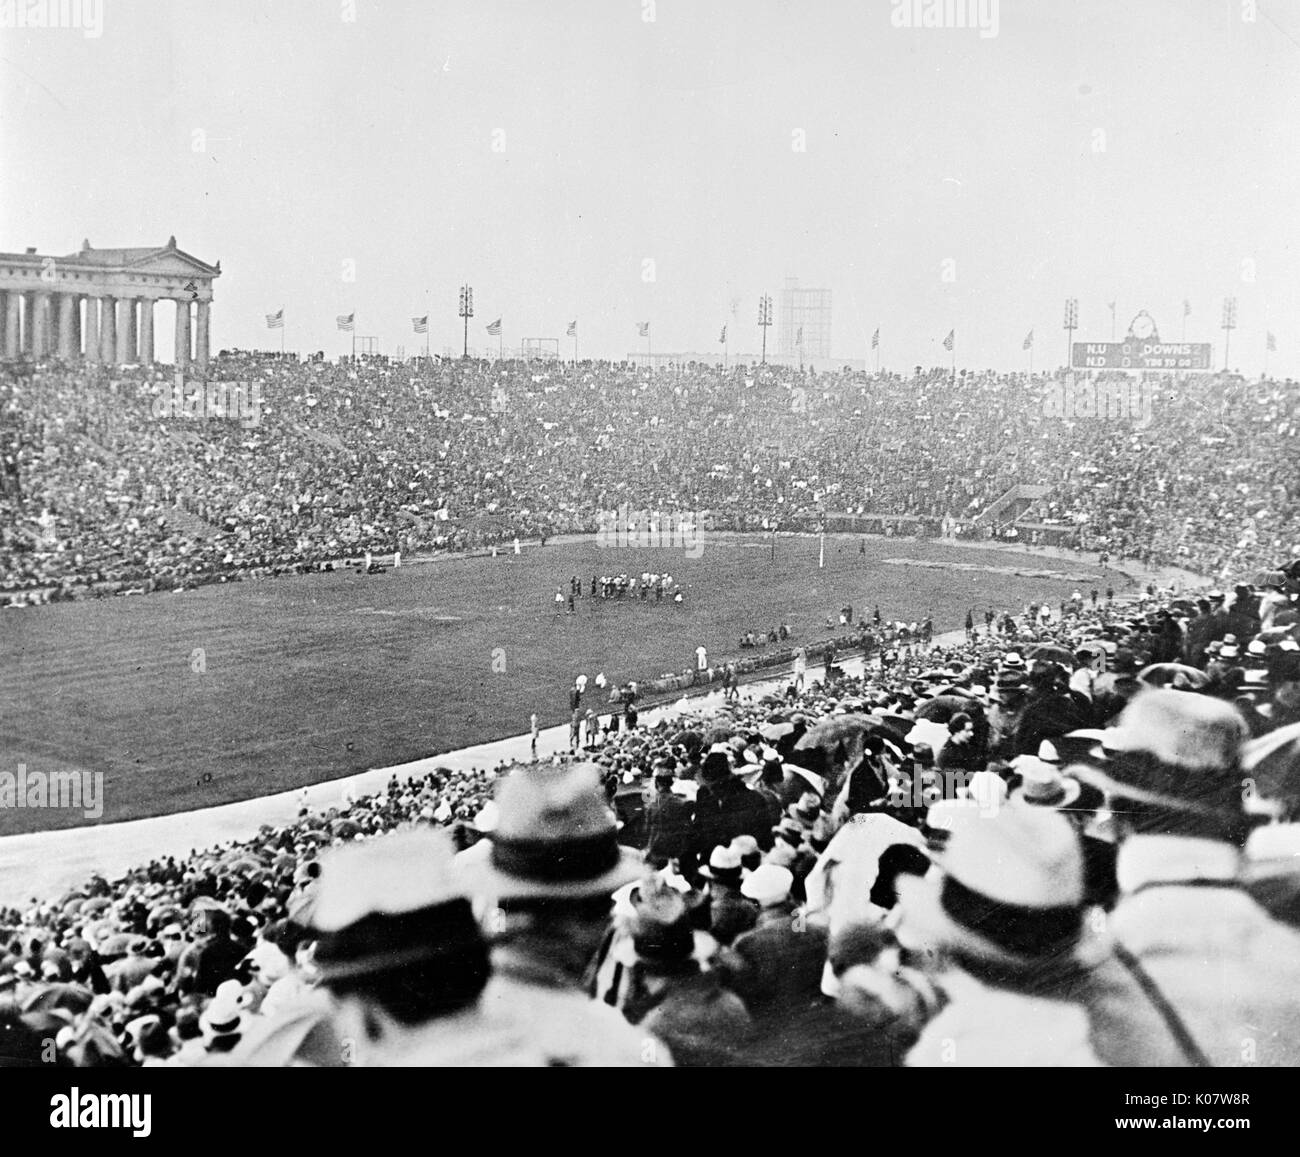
[896,807,1084,967]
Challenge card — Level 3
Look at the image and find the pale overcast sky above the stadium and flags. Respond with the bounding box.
[0,0,1300,376]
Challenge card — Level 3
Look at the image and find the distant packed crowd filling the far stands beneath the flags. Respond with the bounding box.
[0,354,1300,605]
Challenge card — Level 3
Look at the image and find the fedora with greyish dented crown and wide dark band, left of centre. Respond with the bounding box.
[467,763,645,900]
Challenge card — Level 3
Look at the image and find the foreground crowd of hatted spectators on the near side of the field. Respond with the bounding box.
[0,561,1300,1066]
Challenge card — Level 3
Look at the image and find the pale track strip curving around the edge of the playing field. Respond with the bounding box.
[0,532,1190,905]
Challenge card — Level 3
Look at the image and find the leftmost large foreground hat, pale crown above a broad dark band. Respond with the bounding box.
[309,827,486,984]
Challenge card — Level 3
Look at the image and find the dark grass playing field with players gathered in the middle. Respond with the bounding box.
[0,537,1123,835]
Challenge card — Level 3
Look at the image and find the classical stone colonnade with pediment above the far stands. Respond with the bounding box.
[0,237,221,367]
